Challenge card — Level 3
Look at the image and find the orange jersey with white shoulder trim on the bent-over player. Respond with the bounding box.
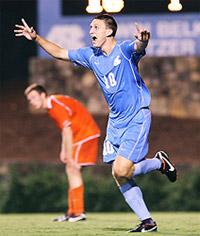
[48,95,100,144]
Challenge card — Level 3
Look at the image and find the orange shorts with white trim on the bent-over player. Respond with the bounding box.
[73,138,98,166]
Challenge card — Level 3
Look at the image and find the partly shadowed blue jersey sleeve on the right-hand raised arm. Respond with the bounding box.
[120,40,146,64]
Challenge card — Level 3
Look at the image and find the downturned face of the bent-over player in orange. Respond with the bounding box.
[27,90,45,109]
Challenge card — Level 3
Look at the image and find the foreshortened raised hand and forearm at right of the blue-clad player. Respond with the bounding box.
[135,23,150,52]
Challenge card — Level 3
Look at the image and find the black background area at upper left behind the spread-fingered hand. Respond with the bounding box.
[0,0,37,86]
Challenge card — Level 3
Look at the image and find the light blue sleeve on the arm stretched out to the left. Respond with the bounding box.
[68,47,93,69]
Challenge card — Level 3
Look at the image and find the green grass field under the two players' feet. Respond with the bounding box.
[0,212,200,236]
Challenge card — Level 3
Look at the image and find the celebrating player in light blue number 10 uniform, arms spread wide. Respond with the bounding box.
[15,14,176,232]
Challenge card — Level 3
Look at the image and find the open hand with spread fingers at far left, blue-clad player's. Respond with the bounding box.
[14,18,37,40]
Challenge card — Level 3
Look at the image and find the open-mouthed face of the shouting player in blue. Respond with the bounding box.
[89,19,112,48]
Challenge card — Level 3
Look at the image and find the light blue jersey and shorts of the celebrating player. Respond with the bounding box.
[68,40,151,163]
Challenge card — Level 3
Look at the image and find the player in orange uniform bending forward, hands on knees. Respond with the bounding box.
[25,84,100,222]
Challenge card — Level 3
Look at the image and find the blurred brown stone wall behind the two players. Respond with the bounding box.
[29,57,200,118]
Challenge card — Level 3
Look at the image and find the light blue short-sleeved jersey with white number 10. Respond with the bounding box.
[69,41,150,127]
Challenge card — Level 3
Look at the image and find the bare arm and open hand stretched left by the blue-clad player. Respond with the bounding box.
[14,19,69,60]
